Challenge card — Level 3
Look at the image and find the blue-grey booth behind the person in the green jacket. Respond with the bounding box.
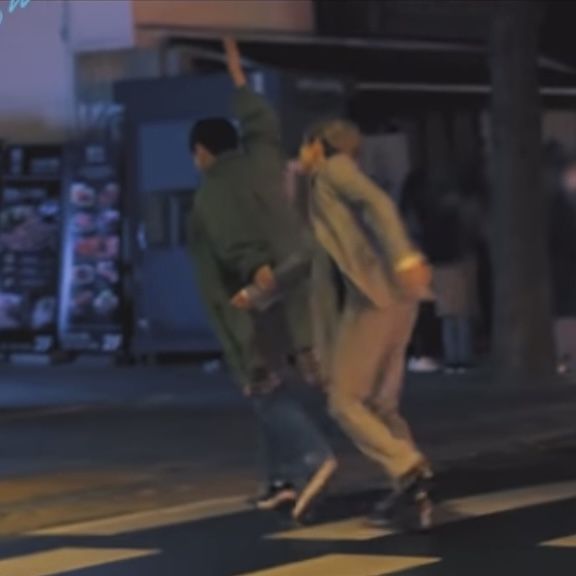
[115,71,346,356]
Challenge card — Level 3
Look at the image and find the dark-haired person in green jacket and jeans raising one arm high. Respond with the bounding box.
[189,40,336,518]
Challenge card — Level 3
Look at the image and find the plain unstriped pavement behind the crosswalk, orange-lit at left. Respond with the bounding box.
[0,366,576,535]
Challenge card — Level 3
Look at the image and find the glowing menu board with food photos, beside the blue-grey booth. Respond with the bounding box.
[60,143,123,352]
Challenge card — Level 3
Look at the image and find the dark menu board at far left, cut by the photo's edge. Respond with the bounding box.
[0,146,62,352]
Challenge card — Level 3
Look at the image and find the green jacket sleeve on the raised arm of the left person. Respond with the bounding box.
[233,86,280,151]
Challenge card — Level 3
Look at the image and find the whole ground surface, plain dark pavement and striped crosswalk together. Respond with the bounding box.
[0,367,576,576]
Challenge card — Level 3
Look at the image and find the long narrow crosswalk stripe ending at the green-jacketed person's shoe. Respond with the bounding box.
[29,496,252,536]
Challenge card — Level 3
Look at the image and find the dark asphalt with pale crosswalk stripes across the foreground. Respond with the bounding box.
[0,451,576,576]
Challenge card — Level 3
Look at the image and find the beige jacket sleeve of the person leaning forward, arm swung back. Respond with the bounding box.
[326,155,423,269]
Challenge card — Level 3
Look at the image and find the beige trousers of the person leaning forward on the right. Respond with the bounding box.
[329,294,422,479]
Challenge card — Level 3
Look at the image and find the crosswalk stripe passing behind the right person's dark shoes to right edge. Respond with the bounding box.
[268,482,576,541]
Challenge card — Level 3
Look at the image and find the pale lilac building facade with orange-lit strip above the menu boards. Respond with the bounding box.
[0,0,314,142]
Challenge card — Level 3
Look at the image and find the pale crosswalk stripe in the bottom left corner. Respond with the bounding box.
[0,548,159,576]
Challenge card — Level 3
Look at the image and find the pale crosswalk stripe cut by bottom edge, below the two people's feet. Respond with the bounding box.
[234,554,440,576]
